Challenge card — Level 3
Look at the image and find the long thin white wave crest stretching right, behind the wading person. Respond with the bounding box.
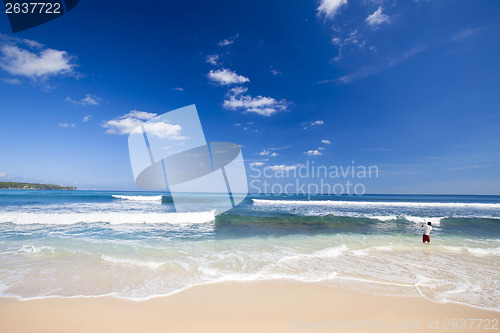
[252,199,500,209]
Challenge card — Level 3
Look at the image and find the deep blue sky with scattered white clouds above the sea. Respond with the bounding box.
[0,0,500,194]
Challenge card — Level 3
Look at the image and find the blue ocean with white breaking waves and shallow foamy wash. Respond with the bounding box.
[0,190,500,311]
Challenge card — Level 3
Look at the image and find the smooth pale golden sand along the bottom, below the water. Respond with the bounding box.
[0,281,500,333]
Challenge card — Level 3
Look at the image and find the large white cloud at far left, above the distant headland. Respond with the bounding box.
[0,39,76,79]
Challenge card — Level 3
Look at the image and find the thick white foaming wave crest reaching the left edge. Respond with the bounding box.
[0,210,215,224]
